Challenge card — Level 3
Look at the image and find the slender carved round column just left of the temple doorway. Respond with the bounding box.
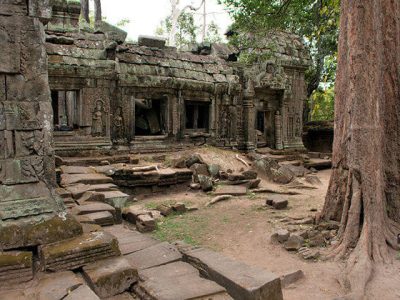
[243,79,256,151]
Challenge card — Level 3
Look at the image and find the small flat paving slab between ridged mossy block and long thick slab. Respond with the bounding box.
[125,242,182,270]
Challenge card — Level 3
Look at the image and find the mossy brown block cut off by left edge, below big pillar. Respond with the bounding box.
[0,251,33,289]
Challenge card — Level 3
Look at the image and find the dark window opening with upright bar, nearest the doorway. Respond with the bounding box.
[185,101,210,132]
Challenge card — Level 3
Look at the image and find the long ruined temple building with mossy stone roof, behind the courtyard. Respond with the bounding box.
[45,2,310,155]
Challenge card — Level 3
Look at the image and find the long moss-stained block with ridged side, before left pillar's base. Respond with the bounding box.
[39,232,121,271]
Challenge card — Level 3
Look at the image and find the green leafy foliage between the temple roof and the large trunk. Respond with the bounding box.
[218,0,340,119]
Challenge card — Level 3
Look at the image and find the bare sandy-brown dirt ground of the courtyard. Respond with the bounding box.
[132,149,400,300]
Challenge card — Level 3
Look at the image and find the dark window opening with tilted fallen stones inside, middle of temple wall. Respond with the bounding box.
[135,99,168,136]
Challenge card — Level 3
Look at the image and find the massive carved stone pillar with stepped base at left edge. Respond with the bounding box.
[0,0,82,252]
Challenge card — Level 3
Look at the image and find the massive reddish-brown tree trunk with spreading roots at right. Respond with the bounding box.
[322,0,400,296]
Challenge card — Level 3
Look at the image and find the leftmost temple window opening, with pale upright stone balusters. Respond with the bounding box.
[51,90,79,131]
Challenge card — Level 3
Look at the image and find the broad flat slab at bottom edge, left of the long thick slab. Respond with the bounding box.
[135,262,232,300]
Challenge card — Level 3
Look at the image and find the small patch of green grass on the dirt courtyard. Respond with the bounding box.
[153,214,207,245]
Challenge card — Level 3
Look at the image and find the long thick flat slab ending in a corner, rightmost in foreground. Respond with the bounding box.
[184,248,283,300]
